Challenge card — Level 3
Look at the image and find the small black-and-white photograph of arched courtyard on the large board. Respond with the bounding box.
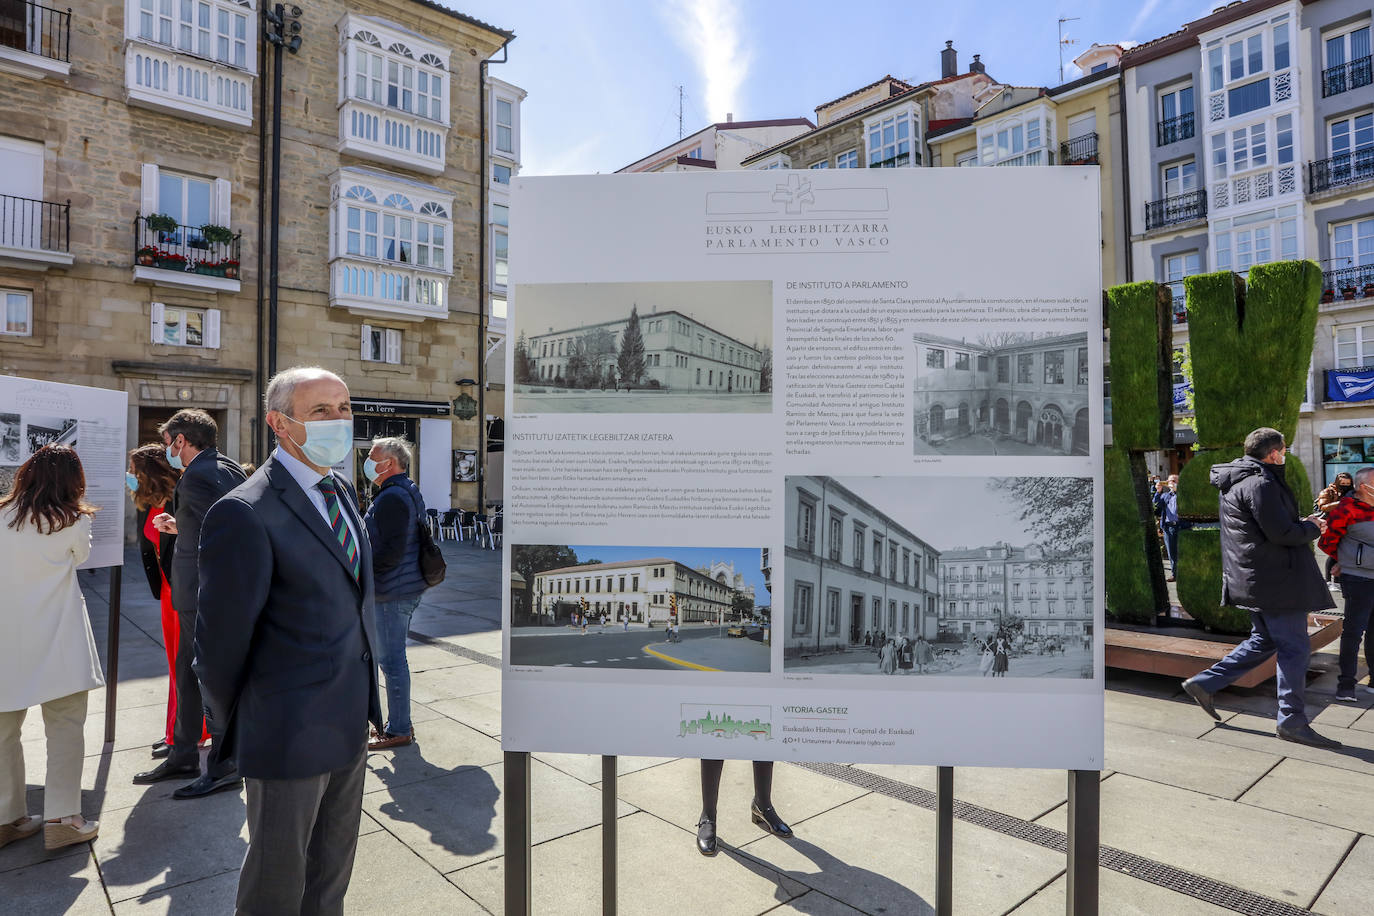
[912,331,1090,456]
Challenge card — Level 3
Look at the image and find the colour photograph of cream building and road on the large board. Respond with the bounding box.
[510,544,771,672]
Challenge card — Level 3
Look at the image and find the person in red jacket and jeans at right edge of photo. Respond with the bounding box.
[1316,467,1374,703]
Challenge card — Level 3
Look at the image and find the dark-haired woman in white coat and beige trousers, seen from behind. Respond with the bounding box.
[0,445,104,849]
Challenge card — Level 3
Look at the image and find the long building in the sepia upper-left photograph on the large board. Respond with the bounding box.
[528,310,764,394]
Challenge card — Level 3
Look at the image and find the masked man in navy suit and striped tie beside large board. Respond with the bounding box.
[195,368,382,916]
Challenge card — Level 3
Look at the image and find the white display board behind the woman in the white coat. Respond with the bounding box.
[0,375,129,569]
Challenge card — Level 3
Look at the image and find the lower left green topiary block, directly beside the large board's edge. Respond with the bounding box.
[1103,450,1160,623]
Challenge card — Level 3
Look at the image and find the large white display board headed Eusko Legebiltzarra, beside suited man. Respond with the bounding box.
[502,168,1103,769]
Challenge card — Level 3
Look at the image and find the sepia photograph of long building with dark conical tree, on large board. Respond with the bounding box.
[513,282,772,413]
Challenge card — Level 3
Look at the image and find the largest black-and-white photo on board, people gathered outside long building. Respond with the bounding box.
[779,477,1094,678]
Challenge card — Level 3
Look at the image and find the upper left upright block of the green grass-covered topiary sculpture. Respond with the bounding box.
[1107,283,1173,449]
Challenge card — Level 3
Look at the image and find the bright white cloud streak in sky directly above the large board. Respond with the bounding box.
[668,0,750,121]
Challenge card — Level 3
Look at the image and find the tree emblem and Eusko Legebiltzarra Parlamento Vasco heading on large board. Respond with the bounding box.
[703,172,890,254]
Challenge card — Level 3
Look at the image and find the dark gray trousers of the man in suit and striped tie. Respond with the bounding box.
[234,747,365,916]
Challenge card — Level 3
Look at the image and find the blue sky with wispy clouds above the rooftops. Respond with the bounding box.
[444,0,1224,174]
